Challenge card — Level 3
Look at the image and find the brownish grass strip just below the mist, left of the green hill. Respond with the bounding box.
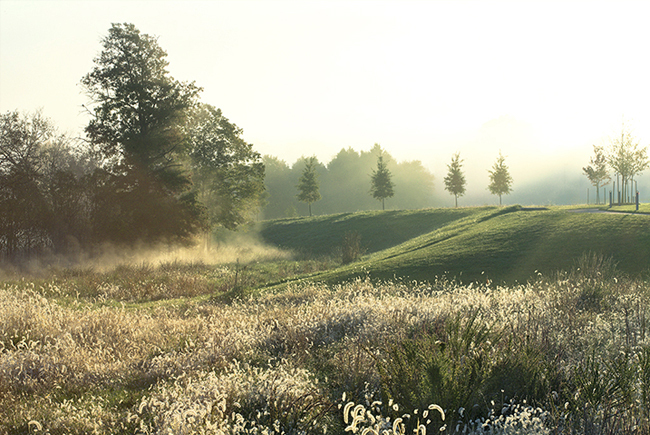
[6,258,338,303]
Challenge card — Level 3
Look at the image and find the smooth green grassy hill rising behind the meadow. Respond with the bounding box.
[261,206,650,282]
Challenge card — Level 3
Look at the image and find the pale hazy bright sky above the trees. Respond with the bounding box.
[0,0,650,204]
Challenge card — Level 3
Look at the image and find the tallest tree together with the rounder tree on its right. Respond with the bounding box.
[82,24,264,247]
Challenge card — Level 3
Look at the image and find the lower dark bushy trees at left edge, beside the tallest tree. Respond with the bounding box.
[0,111,95,260]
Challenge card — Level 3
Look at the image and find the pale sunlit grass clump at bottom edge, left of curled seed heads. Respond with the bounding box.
[135,362,329,434]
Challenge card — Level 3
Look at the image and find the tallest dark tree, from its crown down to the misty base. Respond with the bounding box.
[82,24,205,242]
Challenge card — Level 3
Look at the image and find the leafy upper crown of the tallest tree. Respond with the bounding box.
[81,24,201,180]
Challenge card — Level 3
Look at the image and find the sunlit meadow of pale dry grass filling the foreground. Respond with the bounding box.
[0,252,650,434]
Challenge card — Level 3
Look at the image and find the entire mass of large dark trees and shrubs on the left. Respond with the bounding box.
[0,24,264,259]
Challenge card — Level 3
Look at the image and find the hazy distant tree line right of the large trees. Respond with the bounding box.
[262,144,434,219]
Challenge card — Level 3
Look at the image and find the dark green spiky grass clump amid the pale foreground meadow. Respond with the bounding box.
[378,309,561,430]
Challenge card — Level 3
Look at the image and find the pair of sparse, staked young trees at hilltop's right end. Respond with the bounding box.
[582,126,650,204]
